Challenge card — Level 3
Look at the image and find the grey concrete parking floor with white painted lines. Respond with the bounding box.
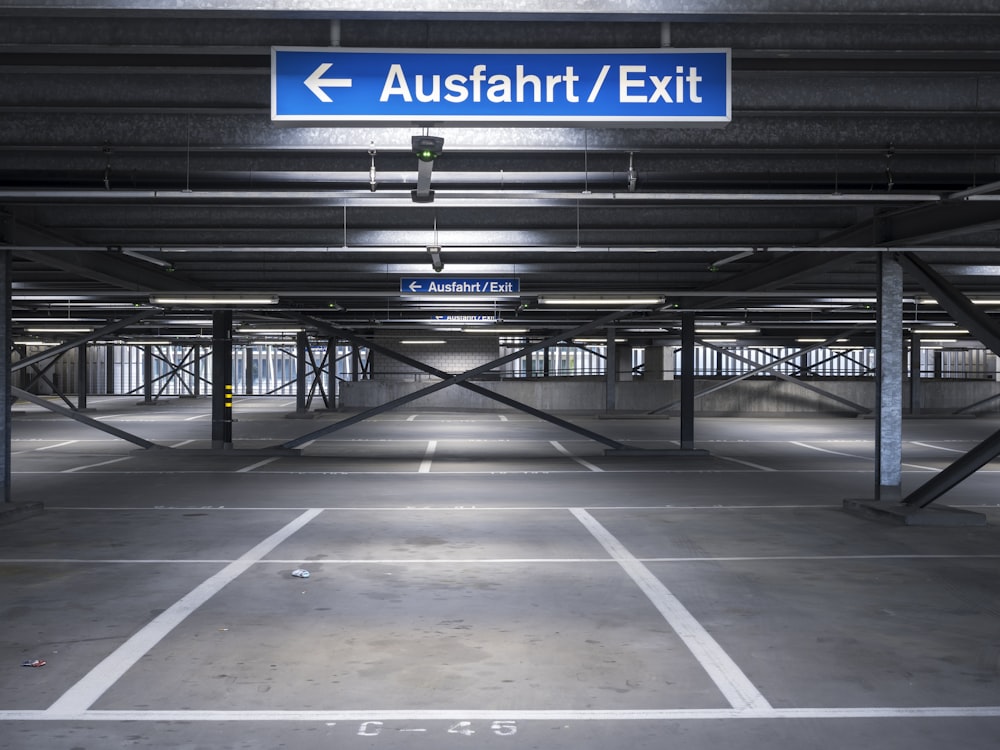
[0,398,1000,750]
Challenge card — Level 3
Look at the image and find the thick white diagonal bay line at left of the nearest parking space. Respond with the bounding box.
[47,509,323,714]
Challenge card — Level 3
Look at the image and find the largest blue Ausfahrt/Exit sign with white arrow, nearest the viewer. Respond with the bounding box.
[271,47,732,126]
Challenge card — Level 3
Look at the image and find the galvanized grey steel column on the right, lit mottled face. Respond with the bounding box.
[875,253,903,502]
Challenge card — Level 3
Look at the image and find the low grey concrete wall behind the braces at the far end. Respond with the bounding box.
[341,378,1000,416]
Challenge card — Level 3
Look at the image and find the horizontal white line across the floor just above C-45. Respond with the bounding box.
[0,706,1000,722]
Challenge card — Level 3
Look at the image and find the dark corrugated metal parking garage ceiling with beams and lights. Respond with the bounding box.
[0,0,1000,343]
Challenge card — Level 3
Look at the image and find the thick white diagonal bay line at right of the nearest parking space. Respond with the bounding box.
[569,508,771,715]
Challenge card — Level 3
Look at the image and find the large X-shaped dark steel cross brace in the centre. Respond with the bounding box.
[279,306,643,450]
